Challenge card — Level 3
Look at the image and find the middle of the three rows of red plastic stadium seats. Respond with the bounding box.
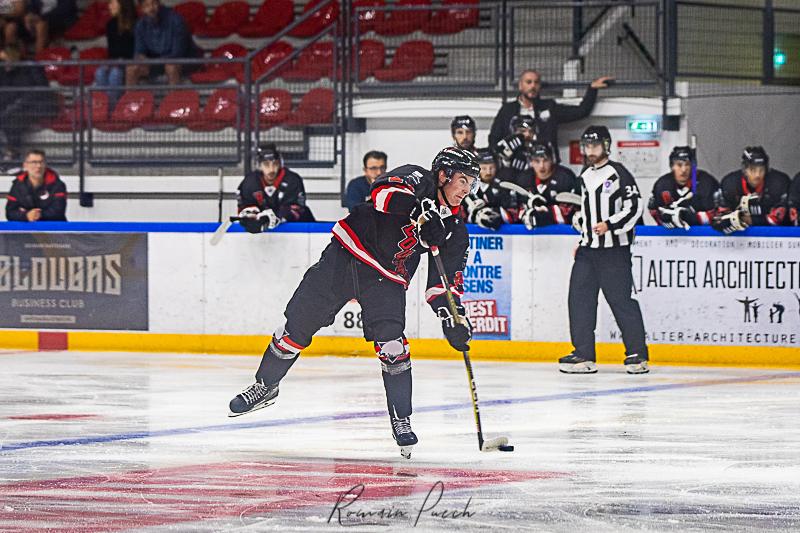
[36,39,434,85]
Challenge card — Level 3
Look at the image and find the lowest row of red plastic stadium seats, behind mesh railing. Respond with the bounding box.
[45,88,334,133]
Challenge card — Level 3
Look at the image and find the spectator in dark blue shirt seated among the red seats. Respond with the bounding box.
[125,0,203,85]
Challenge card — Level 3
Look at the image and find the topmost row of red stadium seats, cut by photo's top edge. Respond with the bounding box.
[64,0,479,41]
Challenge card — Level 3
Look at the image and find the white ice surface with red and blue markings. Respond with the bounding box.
[0,352,800,533]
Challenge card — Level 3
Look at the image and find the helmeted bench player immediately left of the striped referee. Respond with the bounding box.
[517,144,580,229]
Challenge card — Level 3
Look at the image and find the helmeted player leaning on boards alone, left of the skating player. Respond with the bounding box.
[237,143,314,233]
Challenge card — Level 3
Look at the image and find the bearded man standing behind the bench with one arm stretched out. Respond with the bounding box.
[489,69,612,162]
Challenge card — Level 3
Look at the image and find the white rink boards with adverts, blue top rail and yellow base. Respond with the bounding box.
[0,223,800,366]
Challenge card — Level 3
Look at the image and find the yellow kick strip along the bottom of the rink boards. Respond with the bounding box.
[0,330,800,368]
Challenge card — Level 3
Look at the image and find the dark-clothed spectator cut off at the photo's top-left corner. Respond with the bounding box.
[4,0,78,53]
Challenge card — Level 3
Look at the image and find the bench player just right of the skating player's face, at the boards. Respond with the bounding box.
[463,148,514,230]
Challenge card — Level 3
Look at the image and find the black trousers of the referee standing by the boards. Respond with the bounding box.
[568,246,647,361]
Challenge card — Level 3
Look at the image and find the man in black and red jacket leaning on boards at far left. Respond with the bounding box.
[6,150,67,222]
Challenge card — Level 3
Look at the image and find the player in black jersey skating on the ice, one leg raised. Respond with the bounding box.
[230,147,480,457]
